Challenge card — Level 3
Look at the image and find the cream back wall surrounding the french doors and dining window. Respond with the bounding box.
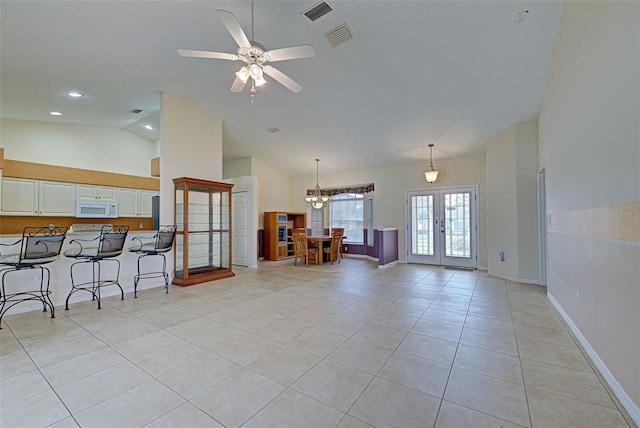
[291,156,487,267]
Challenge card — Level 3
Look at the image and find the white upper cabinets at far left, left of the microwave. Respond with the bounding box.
[0,177,76,217]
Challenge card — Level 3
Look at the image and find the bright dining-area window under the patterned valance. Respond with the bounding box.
[329,193,364,244]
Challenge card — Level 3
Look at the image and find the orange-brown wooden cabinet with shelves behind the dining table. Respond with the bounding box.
[264,211,307,260]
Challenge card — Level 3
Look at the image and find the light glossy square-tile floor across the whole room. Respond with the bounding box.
[0,258,634,428]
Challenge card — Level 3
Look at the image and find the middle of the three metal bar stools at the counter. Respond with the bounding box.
[64,225,129,310]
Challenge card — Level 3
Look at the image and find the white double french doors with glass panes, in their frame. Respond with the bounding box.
[406,187,477,268]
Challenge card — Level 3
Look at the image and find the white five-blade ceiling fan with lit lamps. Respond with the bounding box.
[178,1,315,102]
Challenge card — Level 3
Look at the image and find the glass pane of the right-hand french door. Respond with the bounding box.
[444,192,471,258]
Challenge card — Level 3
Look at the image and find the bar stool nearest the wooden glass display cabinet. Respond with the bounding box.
[129,225,177,298]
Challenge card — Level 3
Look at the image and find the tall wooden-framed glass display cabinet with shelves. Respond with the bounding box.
[173,177,235,286]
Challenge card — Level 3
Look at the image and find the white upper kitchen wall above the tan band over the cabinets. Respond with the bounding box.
[0,119,158,177]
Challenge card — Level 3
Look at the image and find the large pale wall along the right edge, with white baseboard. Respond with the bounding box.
[538,1,640,418]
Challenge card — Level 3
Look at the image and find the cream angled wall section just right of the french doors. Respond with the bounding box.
[486,121,538,283]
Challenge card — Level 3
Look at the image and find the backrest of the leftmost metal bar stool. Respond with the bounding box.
[19,226,67,264]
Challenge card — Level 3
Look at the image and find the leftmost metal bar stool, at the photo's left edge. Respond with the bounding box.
[0,226,67,329]
